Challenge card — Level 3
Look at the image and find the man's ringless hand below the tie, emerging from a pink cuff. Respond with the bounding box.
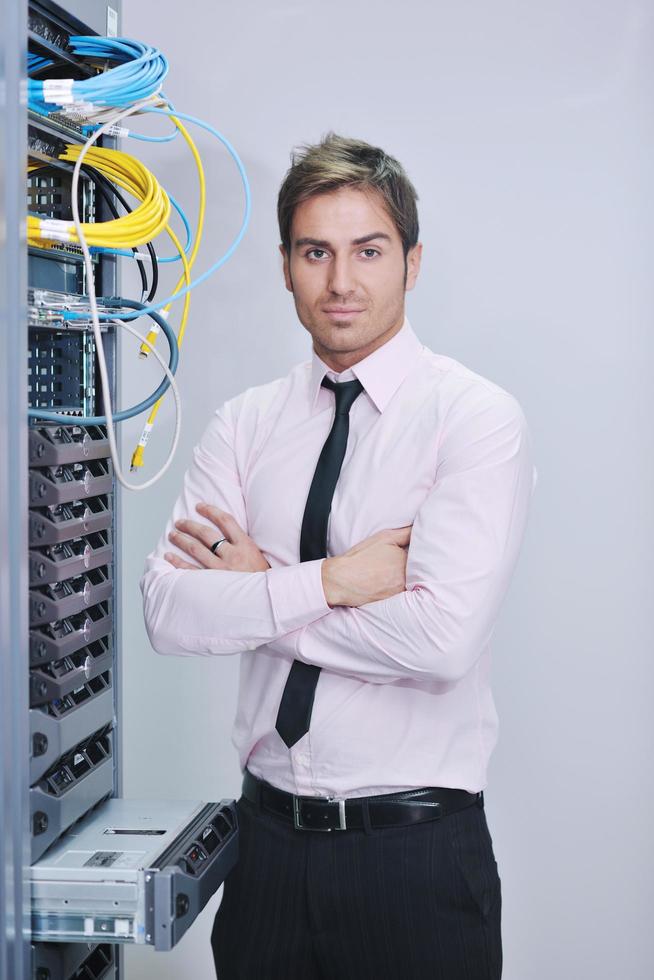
[322,524,413,606]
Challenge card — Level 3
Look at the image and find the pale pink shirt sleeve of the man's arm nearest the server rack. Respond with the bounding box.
[140,402,332,655]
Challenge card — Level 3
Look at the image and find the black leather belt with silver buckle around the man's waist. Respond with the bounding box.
[243,769,484,830]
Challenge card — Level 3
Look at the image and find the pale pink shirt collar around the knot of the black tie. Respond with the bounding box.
[309,316,423,412]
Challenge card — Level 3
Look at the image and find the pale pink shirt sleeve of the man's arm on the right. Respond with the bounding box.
[270,389,537,683]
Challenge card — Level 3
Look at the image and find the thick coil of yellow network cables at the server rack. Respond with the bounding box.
[27,144,171,248]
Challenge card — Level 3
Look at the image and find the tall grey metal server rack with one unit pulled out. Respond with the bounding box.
[0,0,238,980]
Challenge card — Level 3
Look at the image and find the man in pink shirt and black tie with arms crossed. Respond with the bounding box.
[142,133,536,980]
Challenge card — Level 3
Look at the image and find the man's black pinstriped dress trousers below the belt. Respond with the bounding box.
[211,797,502,980]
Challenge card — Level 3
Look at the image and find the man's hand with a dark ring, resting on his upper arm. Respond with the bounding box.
[164,504,270,572]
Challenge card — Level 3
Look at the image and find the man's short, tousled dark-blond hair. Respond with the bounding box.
[277,132,419,264]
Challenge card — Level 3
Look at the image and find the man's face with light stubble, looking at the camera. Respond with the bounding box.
[279,187,422,371]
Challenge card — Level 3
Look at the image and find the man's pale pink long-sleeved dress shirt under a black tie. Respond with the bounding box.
[141,318,537,797]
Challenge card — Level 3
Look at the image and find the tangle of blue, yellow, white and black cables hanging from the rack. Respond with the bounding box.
[28,35,251,490]
